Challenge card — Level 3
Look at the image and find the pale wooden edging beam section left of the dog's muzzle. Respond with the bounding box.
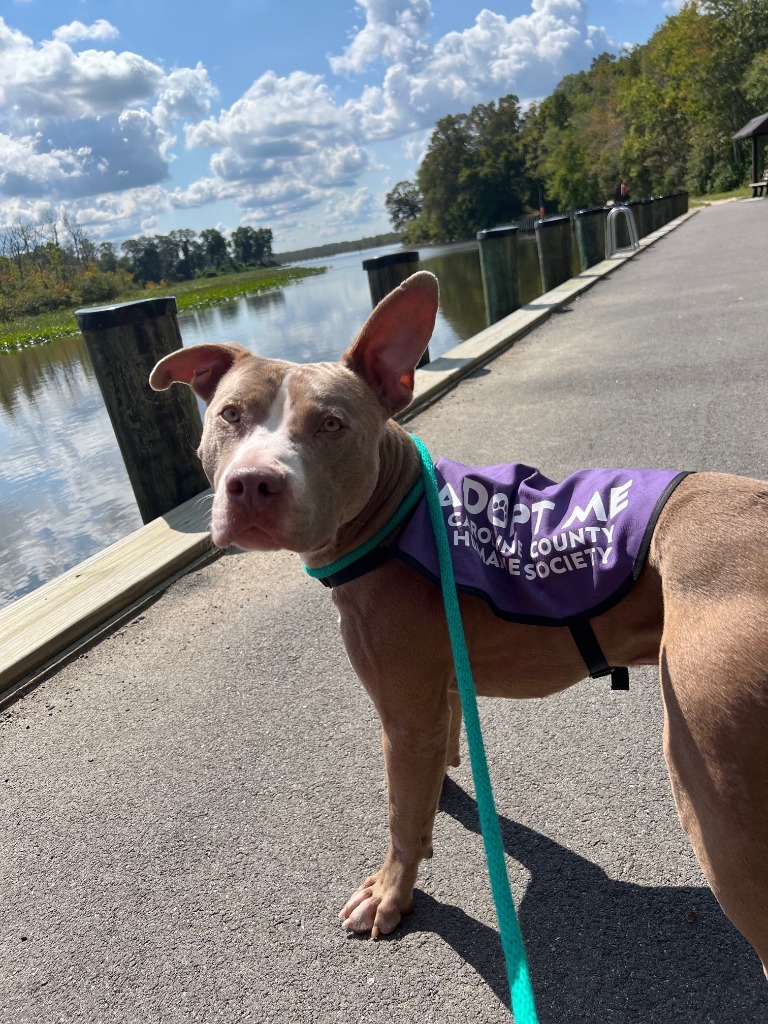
[0,490,213,691]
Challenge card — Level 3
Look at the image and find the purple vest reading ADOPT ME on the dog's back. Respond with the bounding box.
[394,459,686,626]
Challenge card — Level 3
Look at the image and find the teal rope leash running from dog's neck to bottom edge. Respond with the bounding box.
[412,434,539,1024]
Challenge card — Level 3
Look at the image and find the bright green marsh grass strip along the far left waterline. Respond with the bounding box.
[0,267,326,352]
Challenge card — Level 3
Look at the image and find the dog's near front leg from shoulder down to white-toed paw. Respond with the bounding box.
[334,573,454,938]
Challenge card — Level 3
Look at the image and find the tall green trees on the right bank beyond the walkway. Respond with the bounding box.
[386,0,768,244]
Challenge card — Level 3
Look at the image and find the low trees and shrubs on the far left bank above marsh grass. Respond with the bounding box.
[0,209,274,321]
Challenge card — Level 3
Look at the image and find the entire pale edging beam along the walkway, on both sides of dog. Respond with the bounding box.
[0,210,697,707]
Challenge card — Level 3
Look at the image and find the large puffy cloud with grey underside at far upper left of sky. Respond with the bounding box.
[0,18,216,209]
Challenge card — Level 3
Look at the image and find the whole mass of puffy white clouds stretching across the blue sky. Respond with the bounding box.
[0,0,614,244]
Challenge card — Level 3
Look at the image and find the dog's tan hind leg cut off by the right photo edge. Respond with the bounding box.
[660,593,768,977]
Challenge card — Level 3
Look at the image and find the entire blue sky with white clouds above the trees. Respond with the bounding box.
[0,0,678,252]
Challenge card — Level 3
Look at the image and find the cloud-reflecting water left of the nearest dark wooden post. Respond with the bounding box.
[0,338,141,606]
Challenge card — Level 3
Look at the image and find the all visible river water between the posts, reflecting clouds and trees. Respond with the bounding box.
[0,239,552,607]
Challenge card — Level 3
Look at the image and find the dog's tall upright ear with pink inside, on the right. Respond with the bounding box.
[341,270,439,416]
